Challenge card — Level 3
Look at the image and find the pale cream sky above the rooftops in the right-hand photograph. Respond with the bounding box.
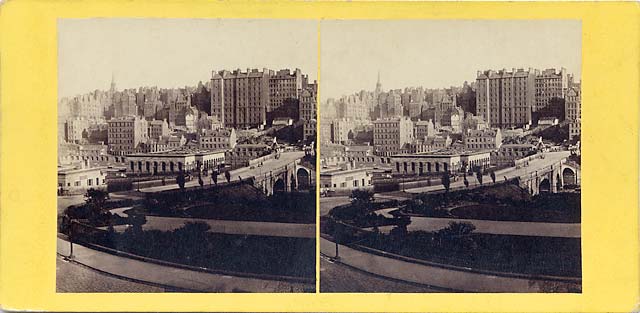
[320,20,582,101]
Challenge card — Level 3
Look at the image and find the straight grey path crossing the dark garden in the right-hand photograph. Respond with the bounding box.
[370,216,580,238]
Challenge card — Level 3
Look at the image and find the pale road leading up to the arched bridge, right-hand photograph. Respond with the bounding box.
[404,151,571,193]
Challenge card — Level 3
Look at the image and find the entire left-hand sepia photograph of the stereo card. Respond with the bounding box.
[52,19,318,293]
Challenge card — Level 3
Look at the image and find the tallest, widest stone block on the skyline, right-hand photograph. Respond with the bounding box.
[476,69,536,128]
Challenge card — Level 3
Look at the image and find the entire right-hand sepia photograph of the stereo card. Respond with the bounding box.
[319,20,582,293]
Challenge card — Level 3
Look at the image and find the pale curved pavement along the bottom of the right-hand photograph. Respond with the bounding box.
[320,238,580,293]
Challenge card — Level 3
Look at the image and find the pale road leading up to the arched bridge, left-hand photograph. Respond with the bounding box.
[140,151,304,192]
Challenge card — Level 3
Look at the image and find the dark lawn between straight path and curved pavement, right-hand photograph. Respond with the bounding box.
[361,232,582,278]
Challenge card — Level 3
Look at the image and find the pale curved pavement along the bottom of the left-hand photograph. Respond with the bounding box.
[57,238,309,292]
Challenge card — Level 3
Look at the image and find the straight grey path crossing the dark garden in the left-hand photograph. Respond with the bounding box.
[104,207,316,238]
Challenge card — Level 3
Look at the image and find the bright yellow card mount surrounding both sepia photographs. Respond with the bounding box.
[0,0,640,312]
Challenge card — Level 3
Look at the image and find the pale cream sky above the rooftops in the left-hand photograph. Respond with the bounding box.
[58,18,318,97]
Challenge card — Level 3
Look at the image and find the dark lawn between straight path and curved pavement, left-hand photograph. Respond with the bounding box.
[74,223,316,278]
